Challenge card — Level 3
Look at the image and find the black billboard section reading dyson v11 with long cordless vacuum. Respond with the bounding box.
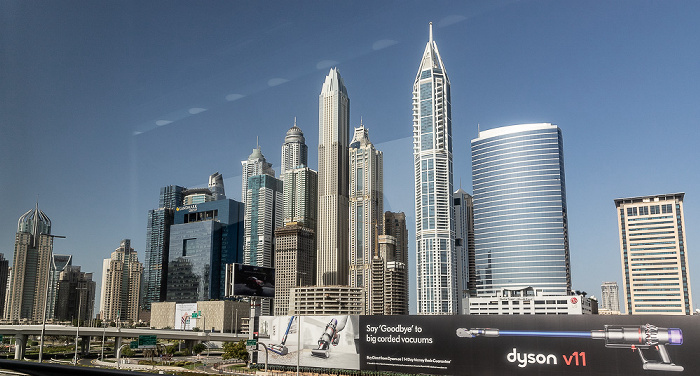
[359,315,700,376]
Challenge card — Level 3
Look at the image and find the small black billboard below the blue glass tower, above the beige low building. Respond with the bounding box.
[226,264,275,298]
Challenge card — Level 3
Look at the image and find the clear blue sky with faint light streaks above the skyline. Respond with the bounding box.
[0,0,700,312]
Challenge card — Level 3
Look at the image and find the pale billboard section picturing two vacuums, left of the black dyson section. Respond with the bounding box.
[258,315,360,369]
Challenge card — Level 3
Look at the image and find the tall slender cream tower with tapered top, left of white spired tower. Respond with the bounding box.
[316,68,350,286]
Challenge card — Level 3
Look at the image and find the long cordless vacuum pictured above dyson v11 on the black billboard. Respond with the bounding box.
[457,324,683,372]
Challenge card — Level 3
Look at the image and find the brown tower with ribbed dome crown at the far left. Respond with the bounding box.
[6,204,53,321]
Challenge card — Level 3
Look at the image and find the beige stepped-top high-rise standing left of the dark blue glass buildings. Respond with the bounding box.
[100,239,143,321]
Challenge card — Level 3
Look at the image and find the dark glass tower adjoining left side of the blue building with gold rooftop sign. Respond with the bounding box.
[142,184,186,310]
